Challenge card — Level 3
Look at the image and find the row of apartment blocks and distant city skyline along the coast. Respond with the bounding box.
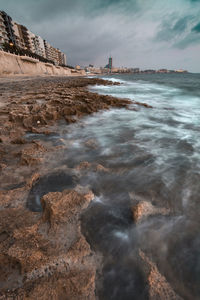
[0,11,188,75]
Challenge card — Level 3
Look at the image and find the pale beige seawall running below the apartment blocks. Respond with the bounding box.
[0,51,85,76]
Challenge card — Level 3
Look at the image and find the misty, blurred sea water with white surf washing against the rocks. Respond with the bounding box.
[30,74,200,300]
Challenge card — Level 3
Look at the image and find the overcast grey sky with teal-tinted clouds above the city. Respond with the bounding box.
[0,0,200,73]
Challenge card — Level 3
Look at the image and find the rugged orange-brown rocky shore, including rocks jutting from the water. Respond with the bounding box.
[0,77,180,300]
